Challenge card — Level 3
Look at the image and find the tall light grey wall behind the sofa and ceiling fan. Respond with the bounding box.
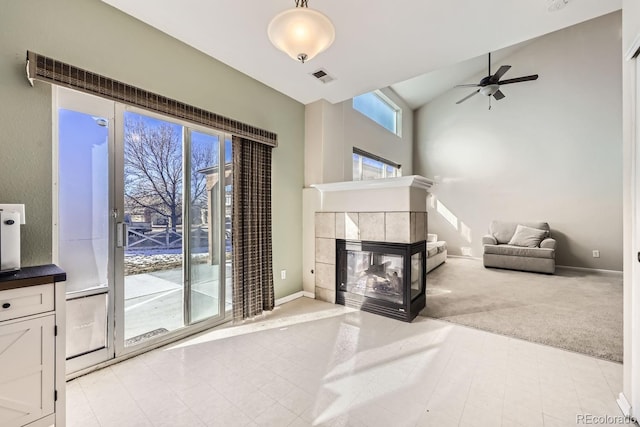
[414,12,622,270]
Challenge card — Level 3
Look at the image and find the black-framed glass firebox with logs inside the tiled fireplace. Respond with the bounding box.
[336,240,427,322]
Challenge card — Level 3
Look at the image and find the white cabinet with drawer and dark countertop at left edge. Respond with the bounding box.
[0,268,65,427]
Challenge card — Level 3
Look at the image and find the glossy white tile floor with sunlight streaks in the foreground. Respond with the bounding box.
[67,298,622,427]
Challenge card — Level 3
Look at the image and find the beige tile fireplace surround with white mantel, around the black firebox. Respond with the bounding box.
[303,175,433,310]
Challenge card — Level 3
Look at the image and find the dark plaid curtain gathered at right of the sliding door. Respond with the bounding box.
[231,136,275,321]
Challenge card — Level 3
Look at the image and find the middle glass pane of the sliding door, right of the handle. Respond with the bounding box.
[118,111,185,347]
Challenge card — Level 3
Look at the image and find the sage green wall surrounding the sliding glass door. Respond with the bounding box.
[0,0,304,298]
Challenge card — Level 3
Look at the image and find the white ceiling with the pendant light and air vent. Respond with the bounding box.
[102,0,622,108]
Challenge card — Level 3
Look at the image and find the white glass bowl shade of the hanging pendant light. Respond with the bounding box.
[267,7,336,62]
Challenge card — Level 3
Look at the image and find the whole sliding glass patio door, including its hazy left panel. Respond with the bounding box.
[54,88,233,372]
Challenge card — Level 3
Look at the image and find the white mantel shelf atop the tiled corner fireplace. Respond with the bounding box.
[311,175,433,212]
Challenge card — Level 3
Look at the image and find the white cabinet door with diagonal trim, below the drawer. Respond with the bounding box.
[0,314,55,427]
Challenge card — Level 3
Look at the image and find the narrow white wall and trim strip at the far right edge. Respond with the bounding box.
[622,0,640,417]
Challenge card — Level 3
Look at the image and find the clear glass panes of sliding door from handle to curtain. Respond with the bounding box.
[116,107,231,353]
